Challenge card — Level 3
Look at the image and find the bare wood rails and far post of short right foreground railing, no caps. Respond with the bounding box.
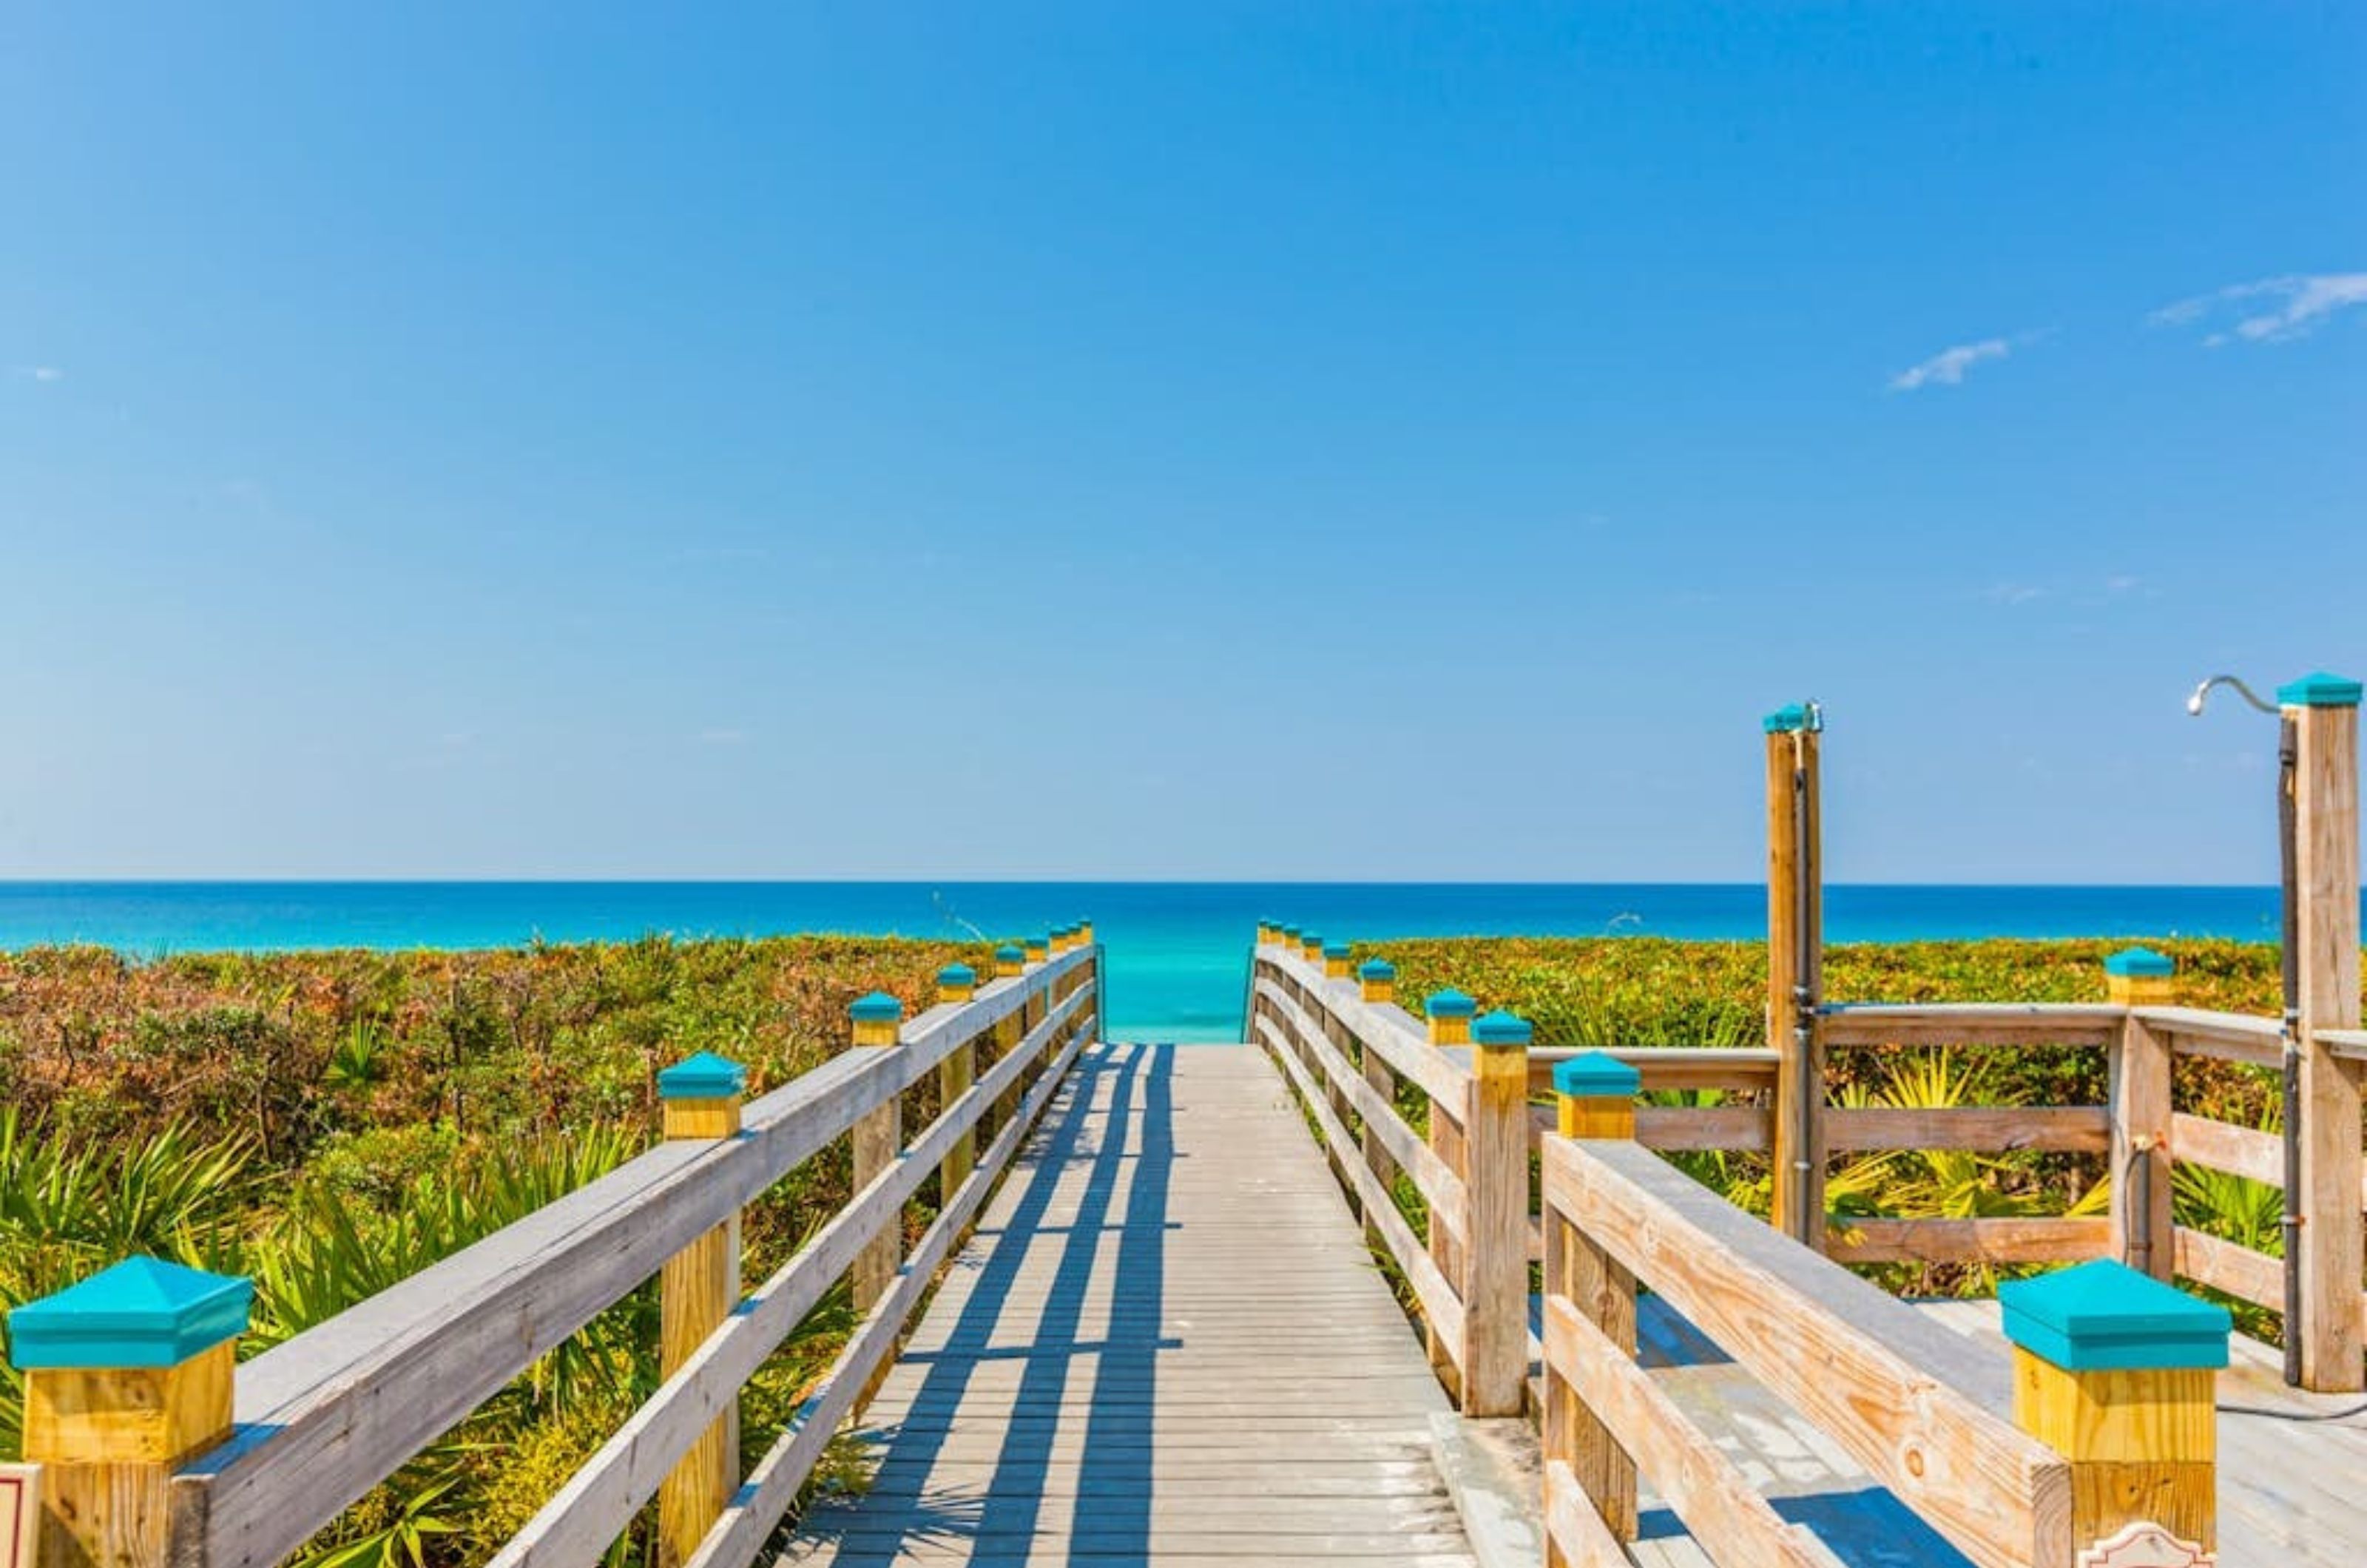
[1543,1137,2071,1568]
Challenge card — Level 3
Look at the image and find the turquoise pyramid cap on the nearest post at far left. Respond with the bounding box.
[7,1257,256,1371]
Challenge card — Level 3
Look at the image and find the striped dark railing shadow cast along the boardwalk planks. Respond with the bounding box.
[807,1044,1179,1568]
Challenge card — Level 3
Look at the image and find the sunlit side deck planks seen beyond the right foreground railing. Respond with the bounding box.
[1629,1296,2367,1568]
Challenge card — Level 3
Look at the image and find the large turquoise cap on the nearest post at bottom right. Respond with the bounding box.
[1998,1257,2235,1371]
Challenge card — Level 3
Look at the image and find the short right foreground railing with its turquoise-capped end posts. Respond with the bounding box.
[1543,1094,2227,1568]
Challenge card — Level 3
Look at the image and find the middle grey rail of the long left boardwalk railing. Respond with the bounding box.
[493,990,1091,1568]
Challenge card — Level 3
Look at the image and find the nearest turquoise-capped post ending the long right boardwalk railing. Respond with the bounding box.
[1463,1011,1529,1416]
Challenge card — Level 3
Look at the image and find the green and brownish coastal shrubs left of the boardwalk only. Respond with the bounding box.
[0,936,992,1568]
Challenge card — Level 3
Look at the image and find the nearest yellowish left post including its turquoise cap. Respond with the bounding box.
[7,1257,256,1568]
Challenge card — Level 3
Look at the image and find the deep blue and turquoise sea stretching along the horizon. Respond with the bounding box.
[0,881,2277,1040]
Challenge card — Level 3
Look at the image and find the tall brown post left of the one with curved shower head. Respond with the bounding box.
[1761,703,1825,1251]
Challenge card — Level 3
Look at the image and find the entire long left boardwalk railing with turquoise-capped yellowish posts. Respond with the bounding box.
[10,926,1101,1568]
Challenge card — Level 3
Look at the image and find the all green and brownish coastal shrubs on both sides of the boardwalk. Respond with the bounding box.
[0,938,2329,1568]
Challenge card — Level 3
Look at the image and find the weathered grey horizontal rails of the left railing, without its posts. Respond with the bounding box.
[141,945,1098,1568]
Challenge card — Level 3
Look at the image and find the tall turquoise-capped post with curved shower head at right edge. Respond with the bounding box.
[2277,675,2367,1393]
